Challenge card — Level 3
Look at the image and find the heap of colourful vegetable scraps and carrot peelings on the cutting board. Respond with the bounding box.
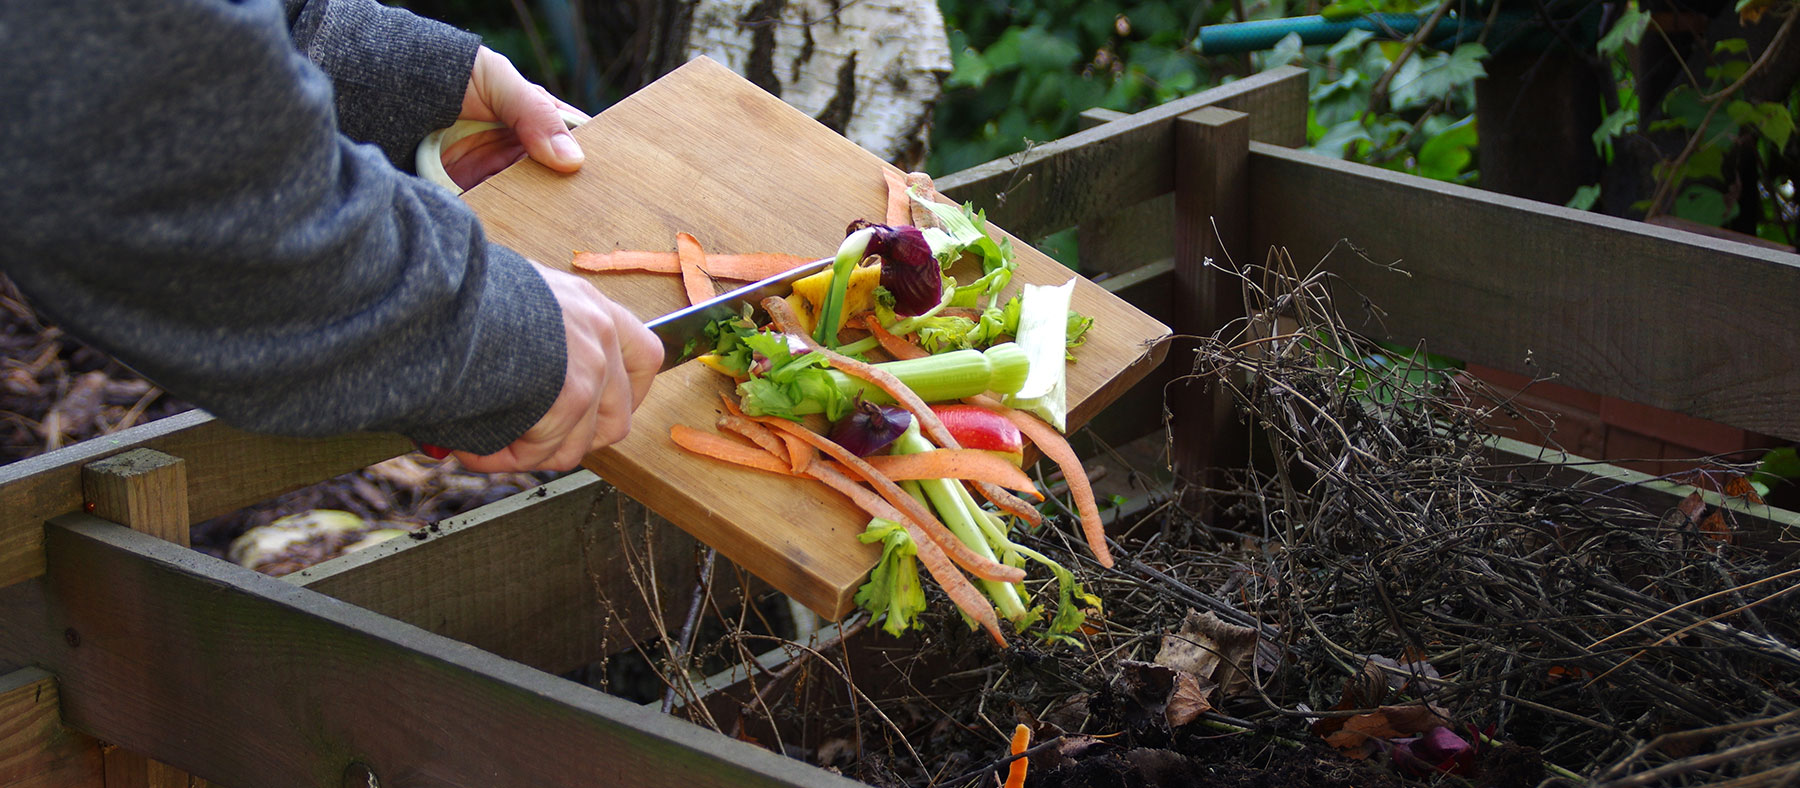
[655,173,1112,646]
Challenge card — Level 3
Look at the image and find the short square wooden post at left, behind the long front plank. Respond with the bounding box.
[81,448,203,788]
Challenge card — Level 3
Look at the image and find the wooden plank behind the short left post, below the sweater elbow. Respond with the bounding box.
[0,410,412,587]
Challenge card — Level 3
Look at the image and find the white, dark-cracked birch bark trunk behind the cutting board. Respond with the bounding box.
[686,0,950,169]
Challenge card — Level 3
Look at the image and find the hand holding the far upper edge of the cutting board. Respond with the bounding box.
[441,47,585,189]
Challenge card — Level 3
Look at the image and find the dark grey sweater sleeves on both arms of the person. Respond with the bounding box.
[0,0,563,453]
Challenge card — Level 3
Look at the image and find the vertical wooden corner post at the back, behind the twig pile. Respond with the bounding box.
[1168,106,1251,482]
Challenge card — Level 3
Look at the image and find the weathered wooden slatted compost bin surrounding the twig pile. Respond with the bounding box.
[0,68,1800,788]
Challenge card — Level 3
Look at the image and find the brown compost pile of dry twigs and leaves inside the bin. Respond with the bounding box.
[662,255,1800,788]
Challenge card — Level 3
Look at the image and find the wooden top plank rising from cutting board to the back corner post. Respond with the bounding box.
[938,67,1307,237]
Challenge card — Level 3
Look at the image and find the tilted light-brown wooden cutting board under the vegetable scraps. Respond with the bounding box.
[464,58,1168,619]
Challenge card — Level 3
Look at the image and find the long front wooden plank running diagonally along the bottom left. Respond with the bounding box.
[35,515,855,788]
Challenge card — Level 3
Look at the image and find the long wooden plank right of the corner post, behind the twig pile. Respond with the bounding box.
[1251,144,1800,439]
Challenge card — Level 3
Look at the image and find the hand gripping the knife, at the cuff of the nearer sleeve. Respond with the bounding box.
[455,266,662,473]
